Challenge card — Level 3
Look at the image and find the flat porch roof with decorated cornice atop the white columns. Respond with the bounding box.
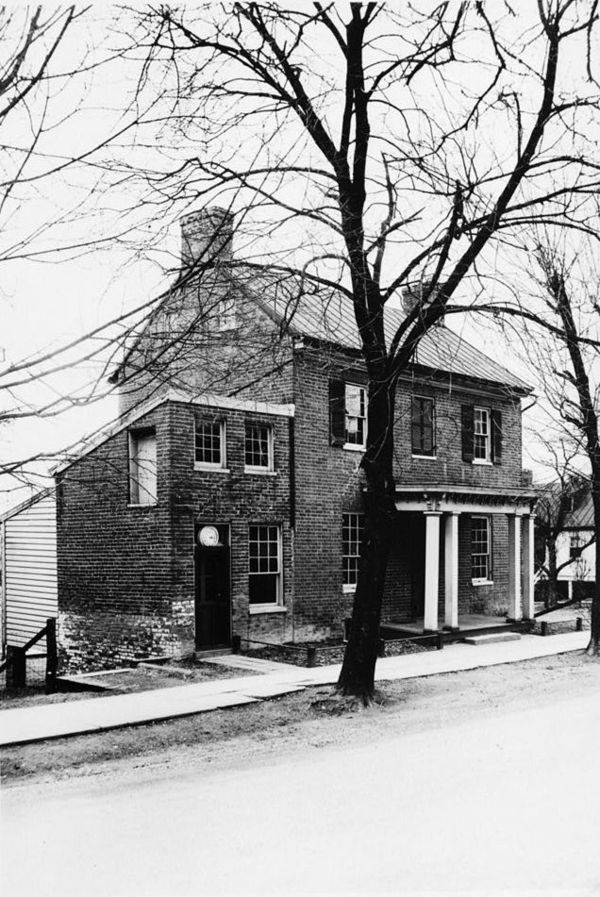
[395,483,537,514]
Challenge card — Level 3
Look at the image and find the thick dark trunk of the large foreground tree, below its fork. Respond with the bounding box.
[337,380,397,704]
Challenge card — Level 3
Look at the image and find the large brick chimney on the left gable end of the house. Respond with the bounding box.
[181,206,233,268]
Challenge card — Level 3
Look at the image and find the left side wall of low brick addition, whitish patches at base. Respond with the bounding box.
[57,406,175,669]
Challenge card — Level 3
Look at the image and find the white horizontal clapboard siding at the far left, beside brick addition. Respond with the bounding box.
[4,493,57,653]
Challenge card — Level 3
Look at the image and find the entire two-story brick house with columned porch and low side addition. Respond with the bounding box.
[51,209,534,668]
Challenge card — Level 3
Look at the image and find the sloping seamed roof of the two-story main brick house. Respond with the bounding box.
[110,263,531,394]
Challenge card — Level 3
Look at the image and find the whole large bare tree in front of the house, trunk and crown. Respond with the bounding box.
[124,0,600,702]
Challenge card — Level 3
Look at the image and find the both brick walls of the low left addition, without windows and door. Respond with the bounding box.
[58,403,293,669]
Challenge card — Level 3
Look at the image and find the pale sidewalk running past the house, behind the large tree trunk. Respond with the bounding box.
[0,632,589,746]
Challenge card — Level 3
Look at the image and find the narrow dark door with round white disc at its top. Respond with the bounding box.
[195,523,231,648]
